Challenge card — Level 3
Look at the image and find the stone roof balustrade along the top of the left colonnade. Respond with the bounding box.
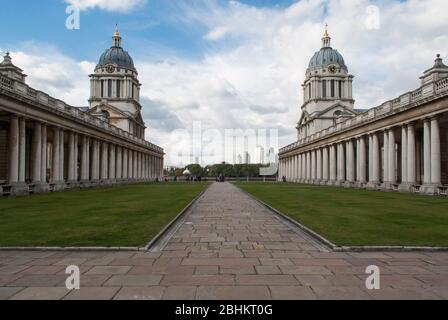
[0,76,163,153]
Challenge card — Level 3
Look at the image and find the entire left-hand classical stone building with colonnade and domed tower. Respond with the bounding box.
[0,30,164,195]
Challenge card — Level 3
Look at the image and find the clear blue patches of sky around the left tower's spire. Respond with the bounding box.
[0,0,294,60]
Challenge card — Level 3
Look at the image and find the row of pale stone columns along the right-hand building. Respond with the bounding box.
[279,116,446,194]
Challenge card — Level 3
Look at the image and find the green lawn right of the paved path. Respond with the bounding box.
[236,183,448,246]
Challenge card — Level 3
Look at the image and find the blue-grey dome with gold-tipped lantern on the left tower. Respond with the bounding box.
[96,26,137,71]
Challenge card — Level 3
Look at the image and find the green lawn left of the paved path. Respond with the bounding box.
[0,183,207,247]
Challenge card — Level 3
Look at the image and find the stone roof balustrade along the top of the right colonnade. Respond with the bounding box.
[279,77,448,153]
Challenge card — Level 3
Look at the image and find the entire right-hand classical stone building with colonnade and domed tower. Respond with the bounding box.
[279,31,448,195]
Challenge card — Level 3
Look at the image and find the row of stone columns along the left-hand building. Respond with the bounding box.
[6,115,163,194]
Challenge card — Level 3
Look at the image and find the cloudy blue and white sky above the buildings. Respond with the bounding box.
[0,0,448,165]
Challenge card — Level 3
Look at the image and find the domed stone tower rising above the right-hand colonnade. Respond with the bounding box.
[297,28,356,140]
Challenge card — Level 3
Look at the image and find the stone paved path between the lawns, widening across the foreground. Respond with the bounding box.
[0,183,448,299]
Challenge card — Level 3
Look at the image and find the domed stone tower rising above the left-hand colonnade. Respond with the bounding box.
[89,27,146,138]
